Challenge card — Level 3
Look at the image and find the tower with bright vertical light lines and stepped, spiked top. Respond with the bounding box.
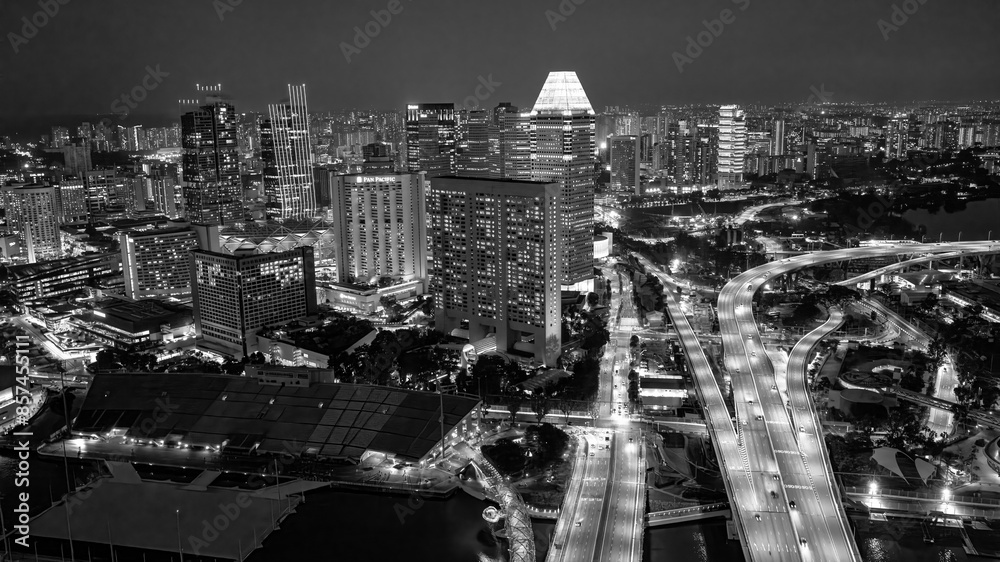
[260,85,316,220]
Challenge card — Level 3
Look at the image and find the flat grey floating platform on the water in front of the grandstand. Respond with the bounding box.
[21,463,301,561]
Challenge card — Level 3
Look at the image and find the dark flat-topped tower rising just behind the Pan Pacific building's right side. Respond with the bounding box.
[406,103,457,178]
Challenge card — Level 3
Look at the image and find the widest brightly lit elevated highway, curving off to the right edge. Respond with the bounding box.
[719,241,1000,562]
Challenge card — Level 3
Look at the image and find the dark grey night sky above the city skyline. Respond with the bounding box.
[0,0,1000,122]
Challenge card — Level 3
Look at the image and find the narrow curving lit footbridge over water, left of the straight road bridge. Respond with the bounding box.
[452,441,535,562]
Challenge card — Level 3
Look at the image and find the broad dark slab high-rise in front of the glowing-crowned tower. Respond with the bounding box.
[427,177,563,366]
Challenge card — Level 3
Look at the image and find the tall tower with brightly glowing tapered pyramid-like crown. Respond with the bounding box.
[531,72,596,290]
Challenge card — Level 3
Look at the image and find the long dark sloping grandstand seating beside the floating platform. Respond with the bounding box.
[73,373,479,461]
